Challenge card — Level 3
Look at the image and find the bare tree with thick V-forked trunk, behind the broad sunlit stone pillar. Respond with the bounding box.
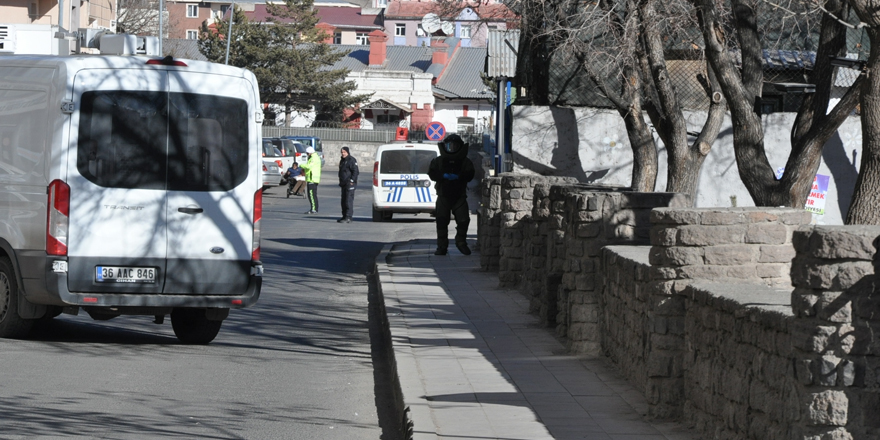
[693,0,864,207]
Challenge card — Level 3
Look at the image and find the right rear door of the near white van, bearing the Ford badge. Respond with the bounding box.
[165,71,254,295]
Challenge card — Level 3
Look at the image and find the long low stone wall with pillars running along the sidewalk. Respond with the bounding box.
[480,176,880,440]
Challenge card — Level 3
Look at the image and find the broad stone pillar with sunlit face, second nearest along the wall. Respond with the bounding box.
[645,208,811,418]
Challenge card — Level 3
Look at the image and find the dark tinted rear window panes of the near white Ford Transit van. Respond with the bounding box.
[77,91,248,191]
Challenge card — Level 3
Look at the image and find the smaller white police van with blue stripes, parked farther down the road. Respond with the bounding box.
[373,143,440,222]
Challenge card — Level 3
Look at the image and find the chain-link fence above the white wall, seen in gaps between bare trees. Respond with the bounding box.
[517,5,870,113]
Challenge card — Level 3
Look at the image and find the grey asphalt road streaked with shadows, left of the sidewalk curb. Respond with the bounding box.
[0,168,434,440]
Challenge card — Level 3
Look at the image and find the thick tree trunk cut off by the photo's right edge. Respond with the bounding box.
[846,28,880,225]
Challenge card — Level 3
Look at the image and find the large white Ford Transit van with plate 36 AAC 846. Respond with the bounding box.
[0,55,263,344]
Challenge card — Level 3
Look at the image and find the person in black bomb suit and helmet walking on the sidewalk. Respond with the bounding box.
[428,134,476,255]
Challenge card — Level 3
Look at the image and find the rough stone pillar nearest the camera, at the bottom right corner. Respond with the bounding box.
[791,226,880,440]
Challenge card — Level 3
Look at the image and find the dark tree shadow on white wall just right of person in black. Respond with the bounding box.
[513,107,610,183]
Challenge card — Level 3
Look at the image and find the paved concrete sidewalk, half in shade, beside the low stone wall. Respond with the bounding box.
[376,240,697,440]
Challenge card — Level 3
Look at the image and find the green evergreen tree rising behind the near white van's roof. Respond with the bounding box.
[199,0,370,121]
